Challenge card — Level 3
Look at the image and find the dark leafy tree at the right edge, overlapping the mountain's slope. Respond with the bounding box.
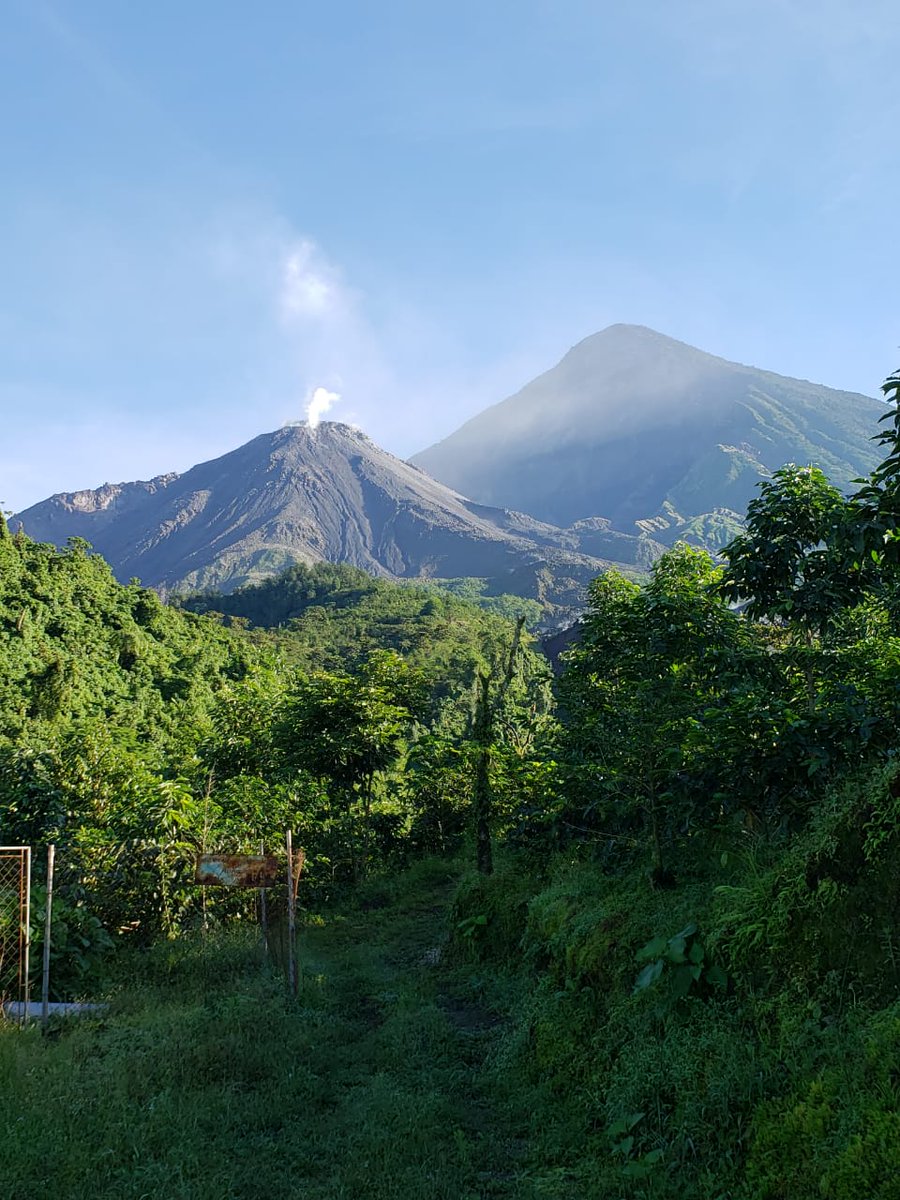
[720,441,900,797]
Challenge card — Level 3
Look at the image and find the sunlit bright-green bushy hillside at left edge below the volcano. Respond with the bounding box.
[0,526,252,742]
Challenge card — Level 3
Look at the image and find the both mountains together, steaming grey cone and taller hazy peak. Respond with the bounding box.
[19,325,884,616]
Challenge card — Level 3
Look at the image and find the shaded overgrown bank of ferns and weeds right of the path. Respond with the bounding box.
[454,766,900,1200]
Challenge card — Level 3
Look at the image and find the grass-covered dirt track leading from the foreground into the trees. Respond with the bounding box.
[296,887,542,1200]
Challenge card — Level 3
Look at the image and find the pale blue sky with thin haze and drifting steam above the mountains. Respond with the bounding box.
[0,0,900,510]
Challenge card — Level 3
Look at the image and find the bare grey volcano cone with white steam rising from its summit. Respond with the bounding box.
[12,421,660,605]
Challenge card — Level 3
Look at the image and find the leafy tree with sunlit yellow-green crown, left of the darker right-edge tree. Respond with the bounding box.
[560,544,760,883]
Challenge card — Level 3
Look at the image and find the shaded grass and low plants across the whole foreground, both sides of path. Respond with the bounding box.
[8,856,900,1200]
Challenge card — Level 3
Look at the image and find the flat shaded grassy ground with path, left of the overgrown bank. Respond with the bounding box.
[0,864,584,1200]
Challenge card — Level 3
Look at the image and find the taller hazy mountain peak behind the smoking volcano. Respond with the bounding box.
[412,325,884,544]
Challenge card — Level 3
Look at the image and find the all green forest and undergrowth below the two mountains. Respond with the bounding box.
[0,367,900,1200]
